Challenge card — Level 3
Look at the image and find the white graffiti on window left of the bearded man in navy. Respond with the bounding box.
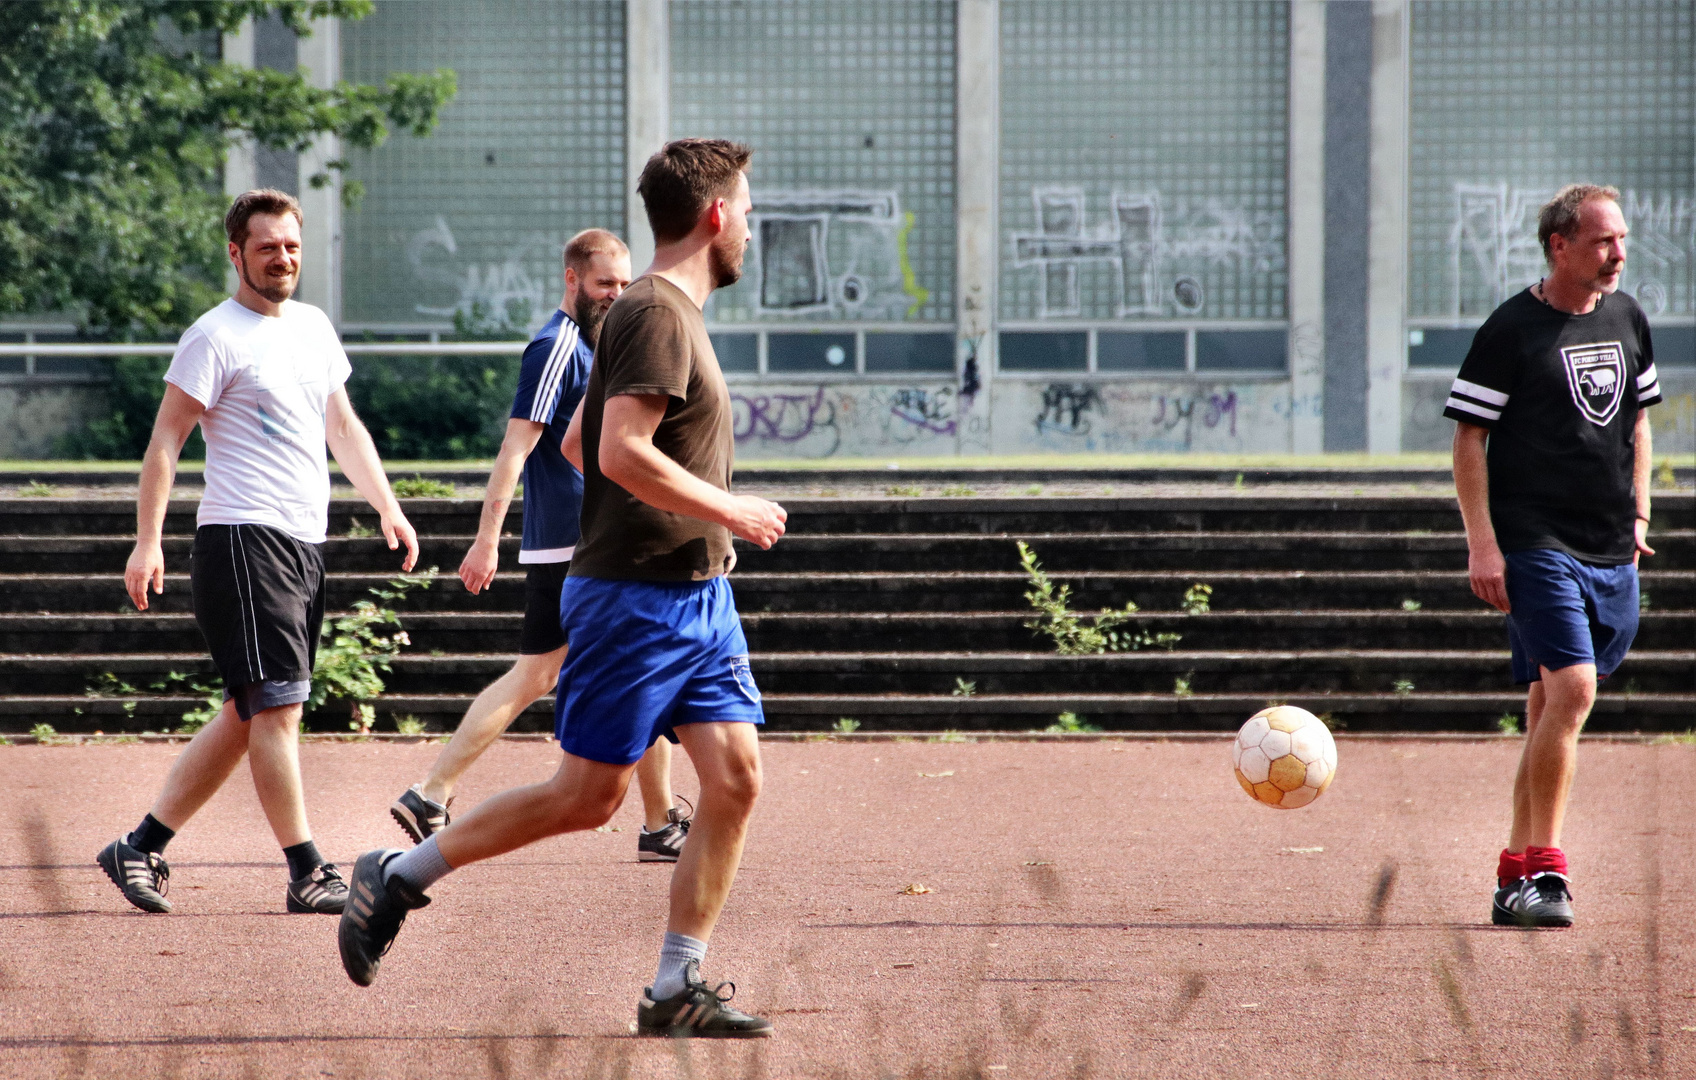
[407,215,558,334]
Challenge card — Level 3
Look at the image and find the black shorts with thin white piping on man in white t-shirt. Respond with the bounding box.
[188,526,324,721]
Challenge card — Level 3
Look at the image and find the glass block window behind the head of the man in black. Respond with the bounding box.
[1408,0,1696,320]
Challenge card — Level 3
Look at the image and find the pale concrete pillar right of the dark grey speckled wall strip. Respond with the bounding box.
[1367,0,1408,454]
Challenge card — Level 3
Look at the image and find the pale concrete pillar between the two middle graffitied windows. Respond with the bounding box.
[955,0,1001,453]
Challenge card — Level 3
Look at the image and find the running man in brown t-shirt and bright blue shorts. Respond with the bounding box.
[339,139,785,1038]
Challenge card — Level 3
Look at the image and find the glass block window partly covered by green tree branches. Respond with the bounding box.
[341,0,624,336]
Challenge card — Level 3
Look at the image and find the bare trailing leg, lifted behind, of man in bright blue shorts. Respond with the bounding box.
[436,754,636,870]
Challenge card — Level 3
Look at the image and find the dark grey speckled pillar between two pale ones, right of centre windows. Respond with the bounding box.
[1325,3,1372,453]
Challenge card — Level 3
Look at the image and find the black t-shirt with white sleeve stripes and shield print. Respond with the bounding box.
[1443,290,1660,565]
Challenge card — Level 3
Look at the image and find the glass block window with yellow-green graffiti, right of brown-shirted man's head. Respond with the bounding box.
[672,0,955,324]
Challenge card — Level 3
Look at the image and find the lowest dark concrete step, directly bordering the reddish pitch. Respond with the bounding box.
[0,692,1696,732]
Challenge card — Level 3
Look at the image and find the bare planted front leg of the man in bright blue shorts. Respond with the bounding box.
[664,724,760,941]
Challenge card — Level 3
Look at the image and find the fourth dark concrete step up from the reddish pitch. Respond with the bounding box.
[0,570,1696,614]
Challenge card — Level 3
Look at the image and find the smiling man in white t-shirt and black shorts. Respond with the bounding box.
[97,188,417,914]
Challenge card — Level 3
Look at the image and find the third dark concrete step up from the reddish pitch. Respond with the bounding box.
[0,610,1696,653]
